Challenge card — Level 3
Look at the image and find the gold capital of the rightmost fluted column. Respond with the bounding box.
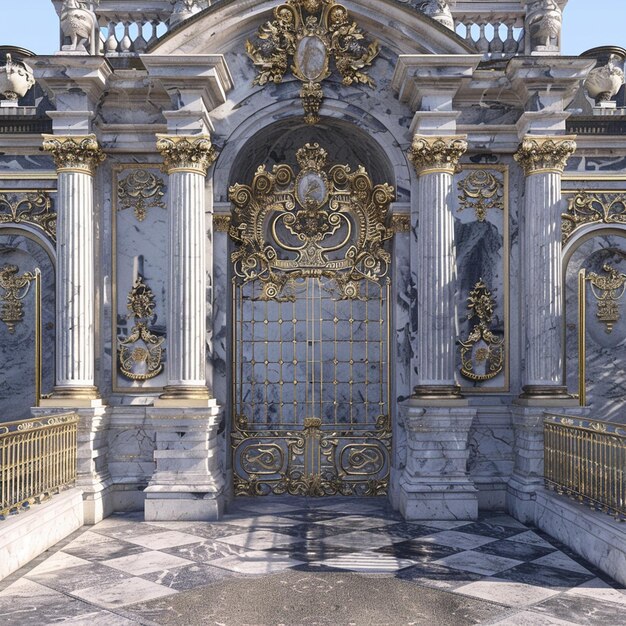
[514,135,576,176]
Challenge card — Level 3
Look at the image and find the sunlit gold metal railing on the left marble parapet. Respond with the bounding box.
[0,413,78,519]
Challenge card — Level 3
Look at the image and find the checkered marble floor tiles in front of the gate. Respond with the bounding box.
[0,498,626,626]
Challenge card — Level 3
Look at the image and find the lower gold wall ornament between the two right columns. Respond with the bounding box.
[459,278,504,382]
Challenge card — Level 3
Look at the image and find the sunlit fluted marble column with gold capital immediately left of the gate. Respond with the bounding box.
[155,135,216,407]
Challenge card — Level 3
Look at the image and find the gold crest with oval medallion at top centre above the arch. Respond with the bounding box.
[246,0,380,124]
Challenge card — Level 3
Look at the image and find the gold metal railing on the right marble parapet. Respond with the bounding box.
[544,415,626,521]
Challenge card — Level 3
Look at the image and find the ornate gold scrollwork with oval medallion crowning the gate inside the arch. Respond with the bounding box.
[229,144,395,300]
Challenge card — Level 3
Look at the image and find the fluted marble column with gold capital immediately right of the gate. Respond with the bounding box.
[409,135,467,399]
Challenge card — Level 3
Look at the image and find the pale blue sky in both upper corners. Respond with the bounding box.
[0,0,626,55]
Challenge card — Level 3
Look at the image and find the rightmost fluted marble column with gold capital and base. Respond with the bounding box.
[515,135,576,399]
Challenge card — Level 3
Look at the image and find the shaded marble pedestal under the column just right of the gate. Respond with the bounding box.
[392,400,478,520]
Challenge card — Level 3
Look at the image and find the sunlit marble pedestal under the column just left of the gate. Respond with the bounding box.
[145,400,224,521]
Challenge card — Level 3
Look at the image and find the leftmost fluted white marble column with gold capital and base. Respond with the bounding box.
[43,135,105,407]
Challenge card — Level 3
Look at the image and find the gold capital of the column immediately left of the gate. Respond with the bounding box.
[157,135,217,176]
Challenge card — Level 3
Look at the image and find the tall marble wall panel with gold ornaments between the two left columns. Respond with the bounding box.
[111,163,167,393]
